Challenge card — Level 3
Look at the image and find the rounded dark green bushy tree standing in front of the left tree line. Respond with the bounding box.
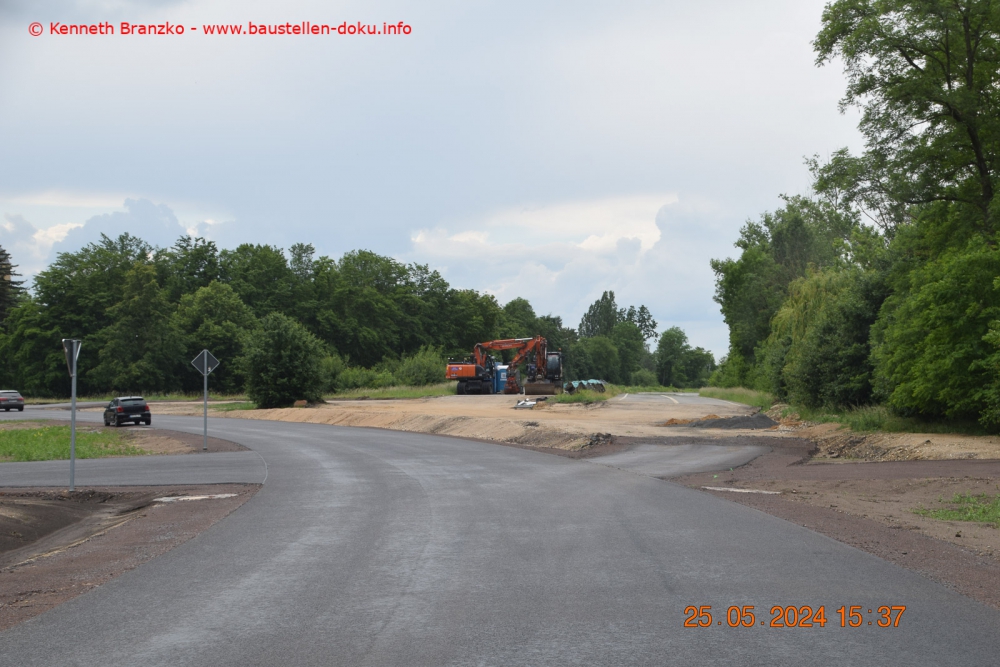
[239,313,327,408]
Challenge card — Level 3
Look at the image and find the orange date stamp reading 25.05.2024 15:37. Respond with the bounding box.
[684,605,906,628]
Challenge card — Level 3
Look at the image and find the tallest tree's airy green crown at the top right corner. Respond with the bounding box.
[813,0,1000,231]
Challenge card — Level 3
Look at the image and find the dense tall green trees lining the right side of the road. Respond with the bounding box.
[712,0,1000,429]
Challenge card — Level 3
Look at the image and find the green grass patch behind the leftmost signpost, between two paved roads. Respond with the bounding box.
[0,426,146,461]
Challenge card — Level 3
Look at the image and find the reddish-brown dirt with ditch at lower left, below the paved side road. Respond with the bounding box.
[0,484,260,630]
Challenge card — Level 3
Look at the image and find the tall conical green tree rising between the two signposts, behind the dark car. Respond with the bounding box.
[89,263,184,392]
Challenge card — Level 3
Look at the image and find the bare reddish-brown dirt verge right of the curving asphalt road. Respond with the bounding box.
[674,449,1000,608]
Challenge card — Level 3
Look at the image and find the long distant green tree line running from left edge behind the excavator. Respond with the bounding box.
[0,233,713,405]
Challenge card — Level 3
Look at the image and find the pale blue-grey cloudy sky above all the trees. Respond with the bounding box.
[0,0,861,357]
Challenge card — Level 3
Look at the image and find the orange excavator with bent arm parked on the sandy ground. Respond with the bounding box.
[445,336,563,395]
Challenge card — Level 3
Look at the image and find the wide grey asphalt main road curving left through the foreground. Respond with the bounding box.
[0,415,1000,666]
